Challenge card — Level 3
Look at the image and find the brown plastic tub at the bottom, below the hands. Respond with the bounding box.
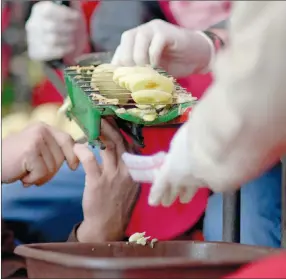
[15,241,279,279]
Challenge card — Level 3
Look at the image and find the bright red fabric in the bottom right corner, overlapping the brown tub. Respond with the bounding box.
[226,252,286,279]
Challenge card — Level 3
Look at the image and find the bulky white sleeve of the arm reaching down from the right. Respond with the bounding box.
[179,1,286,191]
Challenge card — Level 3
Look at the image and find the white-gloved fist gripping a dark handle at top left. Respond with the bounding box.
[26,1,88,61]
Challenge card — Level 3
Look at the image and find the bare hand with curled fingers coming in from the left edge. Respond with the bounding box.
[2,123,79,186]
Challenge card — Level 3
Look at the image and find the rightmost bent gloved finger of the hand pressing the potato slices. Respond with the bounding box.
[149,33,168,66]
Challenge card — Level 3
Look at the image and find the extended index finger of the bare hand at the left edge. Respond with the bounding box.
[47,126,79,170]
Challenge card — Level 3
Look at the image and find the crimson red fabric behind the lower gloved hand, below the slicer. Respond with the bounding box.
[126,127,209,240]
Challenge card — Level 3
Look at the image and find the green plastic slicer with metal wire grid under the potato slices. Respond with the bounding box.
[64,66,195,146]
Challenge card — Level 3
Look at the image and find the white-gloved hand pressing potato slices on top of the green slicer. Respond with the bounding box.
[112,19,215,77]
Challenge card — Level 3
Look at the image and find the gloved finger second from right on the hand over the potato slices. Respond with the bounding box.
[133,32,152,66]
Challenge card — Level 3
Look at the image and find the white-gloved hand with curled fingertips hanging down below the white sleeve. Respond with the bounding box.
[149,124,205,207]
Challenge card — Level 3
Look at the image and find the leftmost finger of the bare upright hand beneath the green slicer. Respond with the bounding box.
[73,143,101,179]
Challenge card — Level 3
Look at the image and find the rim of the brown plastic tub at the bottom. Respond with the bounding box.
[14,241,282,270]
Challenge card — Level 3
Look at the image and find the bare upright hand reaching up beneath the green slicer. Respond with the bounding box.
[74,120,139,242]
